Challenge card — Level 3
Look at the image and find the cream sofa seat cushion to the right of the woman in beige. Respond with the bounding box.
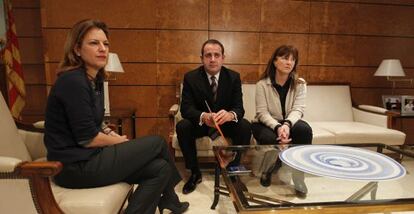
[312,121,405,145]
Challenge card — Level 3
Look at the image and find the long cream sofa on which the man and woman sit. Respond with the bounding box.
[170,84,405,157]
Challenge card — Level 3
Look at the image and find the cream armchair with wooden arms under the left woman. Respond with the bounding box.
[0,93,132,214]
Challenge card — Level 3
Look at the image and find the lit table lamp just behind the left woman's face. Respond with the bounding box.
[104,53,124,116]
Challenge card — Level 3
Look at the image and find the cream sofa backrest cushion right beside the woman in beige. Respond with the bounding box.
[304,85,354,121]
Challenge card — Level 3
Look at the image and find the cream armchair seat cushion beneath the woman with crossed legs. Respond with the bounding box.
[51,182,132,214]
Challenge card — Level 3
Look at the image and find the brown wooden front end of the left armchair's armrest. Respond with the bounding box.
[16,161,62,177]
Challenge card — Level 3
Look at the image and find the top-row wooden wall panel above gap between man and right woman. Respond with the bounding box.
[210,0,261,31]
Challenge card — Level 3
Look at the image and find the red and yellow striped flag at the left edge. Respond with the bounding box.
[2,0,26,119]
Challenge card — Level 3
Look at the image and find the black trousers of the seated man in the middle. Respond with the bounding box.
[176,119,252,169]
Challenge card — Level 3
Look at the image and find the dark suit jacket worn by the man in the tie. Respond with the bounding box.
[180,66,244,124]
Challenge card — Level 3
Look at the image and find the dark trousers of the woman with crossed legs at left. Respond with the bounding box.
[55,136,181,214]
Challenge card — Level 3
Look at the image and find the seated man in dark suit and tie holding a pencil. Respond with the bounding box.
[176,39,251,194]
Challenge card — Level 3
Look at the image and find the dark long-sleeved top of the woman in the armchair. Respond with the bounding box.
[44,68,104,163]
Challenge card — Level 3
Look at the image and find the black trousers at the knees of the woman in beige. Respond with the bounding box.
[252,120,313,145]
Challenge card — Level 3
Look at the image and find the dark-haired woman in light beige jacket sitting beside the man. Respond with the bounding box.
[252,45,312,195]
